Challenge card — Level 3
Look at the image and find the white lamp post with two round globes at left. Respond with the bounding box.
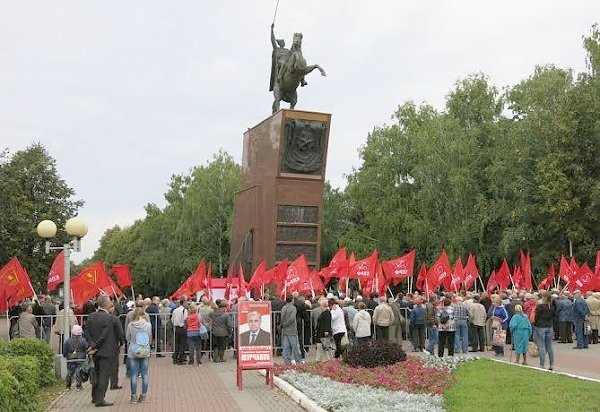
[37,217,87,342]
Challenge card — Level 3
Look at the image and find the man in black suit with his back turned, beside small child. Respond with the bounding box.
[85,296,125,407]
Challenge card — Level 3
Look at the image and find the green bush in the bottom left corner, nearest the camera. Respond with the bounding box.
[0,355,40,411]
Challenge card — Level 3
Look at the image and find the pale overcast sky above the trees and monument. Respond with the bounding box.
[0,0,600,261]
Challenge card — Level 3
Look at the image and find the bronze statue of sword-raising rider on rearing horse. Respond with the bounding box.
[269,24,325,113]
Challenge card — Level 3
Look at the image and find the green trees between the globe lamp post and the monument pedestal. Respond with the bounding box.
[90,152,240,295]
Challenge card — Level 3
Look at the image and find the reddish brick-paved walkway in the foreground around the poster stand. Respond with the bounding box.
[48,354,303,412]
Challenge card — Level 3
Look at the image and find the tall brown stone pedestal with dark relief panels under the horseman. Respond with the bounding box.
[230,109,331,279]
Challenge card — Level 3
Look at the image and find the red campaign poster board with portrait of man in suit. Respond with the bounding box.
[237,301,273,369]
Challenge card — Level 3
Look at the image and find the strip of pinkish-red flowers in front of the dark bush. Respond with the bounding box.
[275,356,454,395]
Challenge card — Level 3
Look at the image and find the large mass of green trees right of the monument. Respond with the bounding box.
[323,26,600,284]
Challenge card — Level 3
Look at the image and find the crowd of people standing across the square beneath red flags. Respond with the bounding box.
[9,284,600,406]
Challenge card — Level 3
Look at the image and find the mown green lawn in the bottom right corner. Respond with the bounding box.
[444,359,600,412]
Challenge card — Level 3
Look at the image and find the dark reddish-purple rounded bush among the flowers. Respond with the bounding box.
[342,341,406,368]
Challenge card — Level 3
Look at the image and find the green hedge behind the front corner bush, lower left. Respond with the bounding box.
[0,338,56,386]
